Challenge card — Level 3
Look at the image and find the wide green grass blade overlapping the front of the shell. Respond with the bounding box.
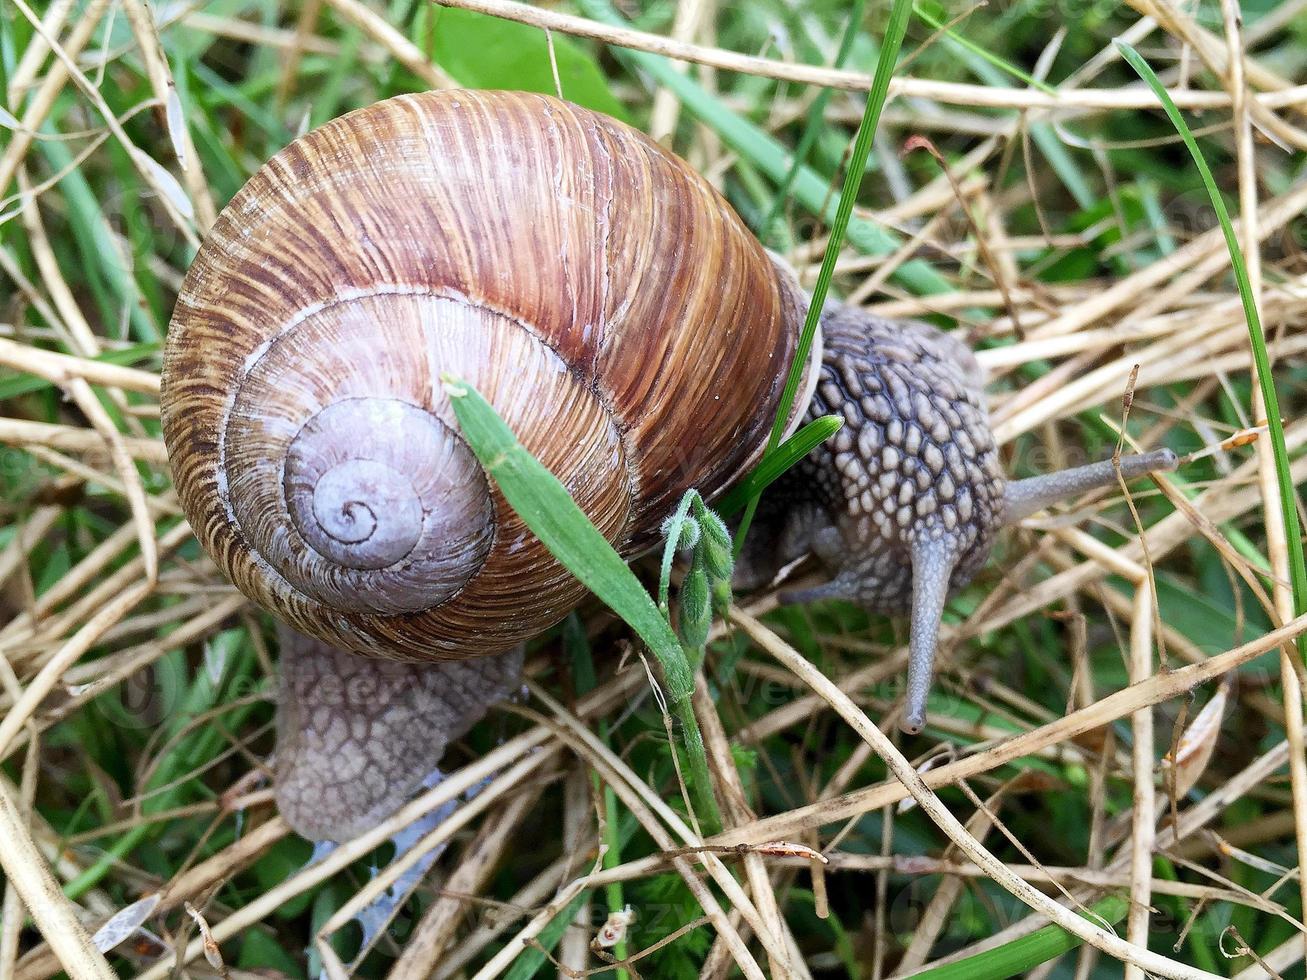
[443,378,721,832]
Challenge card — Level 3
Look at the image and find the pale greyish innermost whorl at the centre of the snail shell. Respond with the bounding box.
[223,397,494,614]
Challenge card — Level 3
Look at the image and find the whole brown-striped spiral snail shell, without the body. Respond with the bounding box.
[163,91,801,659]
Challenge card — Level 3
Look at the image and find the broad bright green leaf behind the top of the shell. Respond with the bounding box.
[434,8,626,120]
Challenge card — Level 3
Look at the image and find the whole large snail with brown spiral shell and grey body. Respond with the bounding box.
[162,90,1174,840]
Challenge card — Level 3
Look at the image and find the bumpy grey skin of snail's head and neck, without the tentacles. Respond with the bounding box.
[789,306,1006,612]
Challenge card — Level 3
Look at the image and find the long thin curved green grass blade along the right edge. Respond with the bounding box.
[1114,39,1307,662]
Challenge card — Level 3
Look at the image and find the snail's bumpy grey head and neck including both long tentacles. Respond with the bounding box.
[736,303,1176,732]
